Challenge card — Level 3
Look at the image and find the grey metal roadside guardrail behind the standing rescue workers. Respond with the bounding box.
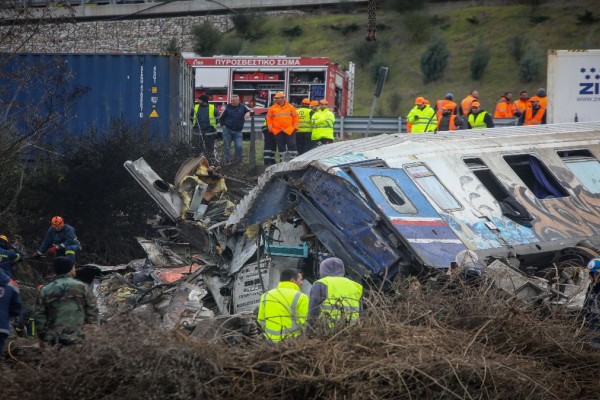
[244,114,518,137]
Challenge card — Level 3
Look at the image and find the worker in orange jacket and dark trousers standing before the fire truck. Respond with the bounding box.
[265,92,300,163]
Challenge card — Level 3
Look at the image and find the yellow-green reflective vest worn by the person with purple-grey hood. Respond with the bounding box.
[317,276,363,328]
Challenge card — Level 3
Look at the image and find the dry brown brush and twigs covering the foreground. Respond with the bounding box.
[0,284,600,399]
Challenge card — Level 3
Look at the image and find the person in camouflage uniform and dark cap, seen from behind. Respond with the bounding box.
[35,257,98,345]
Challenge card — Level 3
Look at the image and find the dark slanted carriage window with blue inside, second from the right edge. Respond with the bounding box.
[504,154,569,199]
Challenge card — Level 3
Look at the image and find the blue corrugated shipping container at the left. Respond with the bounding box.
[0,54,194,141]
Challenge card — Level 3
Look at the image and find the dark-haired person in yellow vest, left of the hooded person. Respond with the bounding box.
[257,269,308,342]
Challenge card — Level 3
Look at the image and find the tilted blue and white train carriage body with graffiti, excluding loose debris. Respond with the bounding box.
[227,123,600,290]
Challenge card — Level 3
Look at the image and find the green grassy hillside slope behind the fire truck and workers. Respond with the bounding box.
[224,0,600,116]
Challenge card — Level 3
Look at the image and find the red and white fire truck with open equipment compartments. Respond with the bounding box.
[183,53,354,115]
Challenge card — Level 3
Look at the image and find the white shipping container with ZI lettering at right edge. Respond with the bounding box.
[547,50,600,124]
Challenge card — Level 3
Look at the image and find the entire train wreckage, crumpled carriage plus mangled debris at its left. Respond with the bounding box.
[115,122,600,335]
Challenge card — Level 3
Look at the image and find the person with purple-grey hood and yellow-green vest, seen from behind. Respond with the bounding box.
[308,257,363,328]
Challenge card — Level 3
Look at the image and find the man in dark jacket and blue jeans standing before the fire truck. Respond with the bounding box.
[219,94,252,164]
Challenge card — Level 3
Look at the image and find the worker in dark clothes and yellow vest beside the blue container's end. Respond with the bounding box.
[191,94,219,163]
